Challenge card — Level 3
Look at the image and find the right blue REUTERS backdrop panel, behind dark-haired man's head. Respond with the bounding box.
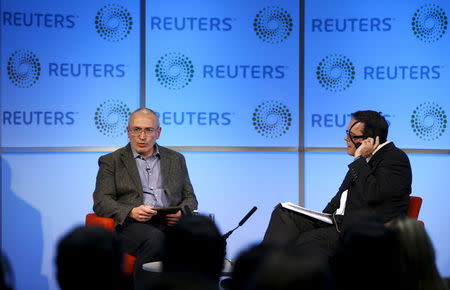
[304,0,450,149]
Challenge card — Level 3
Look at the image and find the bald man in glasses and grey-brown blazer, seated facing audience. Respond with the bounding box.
[94,108,197,289]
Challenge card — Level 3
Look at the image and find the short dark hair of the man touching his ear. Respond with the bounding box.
[351,111,389,144]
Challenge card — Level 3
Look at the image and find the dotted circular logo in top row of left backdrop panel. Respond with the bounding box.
[95,4,133,41]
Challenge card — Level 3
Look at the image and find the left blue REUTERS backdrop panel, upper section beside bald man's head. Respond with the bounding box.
[0,0,140,147]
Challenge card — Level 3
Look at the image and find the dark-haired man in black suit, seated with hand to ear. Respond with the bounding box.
[263,111,412,258]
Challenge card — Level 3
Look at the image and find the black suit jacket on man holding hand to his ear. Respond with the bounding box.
[323,142,412,228]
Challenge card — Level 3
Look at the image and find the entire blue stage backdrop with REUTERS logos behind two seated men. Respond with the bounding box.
[0,0,450,289]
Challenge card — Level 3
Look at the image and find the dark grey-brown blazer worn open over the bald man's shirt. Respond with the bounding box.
[94,144,197,224]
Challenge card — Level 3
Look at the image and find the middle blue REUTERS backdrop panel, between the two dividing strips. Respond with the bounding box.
[146,0,300,146]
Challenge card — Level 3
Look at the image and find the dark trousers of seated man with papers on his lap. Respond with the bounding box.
[263,205,339,259]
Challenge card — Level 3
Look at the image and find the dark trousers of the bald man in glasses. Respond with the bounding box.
[116,220,168,290]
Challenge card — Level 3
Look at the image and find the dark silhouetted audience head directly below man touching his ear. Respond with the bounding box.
[330,220,404,290]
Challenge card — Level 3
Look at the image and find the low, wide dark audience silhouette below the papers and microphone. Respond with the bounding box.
[236,244,334,290]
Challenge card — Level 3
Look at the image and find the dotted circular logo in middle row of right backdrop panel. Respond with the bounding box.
[316,54,355,92]
